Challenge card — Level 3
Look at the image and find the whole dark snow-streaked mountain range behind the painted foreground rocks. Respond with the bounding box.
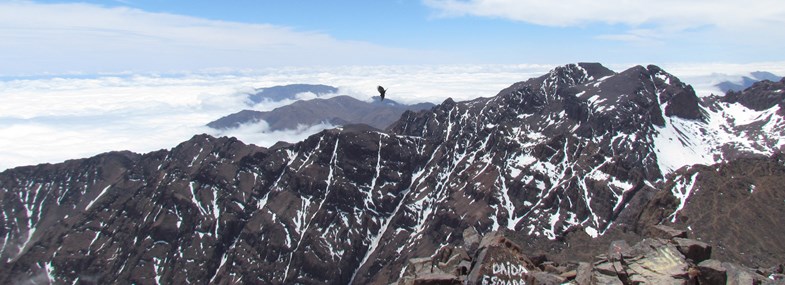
[0,63,785,284]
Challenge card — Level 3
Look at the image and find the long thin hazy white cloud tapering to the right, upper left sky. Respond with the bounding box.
[0,1,438,75]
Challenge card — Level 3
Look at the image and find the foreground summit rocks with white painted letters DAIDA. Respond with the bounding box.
[402,225,785,285]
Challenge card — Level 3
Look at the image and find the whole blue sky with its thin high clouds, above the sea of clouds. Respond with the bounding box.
[0,0,785,76]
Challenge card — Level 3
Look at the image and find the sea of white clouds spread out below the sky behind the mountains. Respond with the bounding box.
[0,63,785,171]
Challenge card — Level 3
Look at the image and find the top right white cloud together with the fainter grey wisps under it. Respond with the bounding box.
[423,0,785,45]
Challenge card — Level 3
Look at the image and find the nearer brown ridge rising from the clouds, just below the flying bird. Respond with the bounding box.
[207,95,433,131]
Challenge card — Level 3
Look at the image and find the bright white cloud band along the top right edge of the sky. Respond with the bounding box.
[424,0,785,28]
